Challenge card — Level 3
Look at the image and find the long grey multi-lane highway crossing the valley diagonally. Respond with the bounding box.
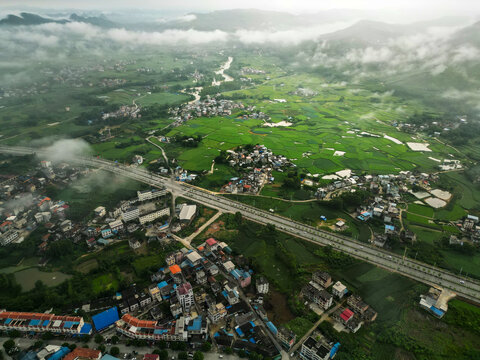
[0,146,480,304]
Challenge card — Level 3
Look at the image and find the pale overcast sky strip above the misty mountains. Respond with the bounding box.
[0,0,480,19]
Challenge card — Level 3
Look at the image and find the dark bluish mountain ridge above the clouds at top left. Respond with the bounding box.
[0,12,116,28]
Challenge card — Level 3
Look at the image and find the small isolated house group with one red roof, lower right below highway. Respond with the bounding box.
[301,271,377,333]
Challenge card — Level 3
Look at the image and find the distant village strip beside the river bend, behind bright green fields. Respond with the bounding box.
[169,96,249,126]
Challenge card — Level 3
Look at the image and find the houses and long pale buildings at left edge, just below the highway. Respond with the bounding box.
[0,155,176,258]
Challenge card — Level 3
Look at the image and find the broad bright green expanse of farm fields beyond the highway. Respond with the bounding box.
[168,75,456,175]
